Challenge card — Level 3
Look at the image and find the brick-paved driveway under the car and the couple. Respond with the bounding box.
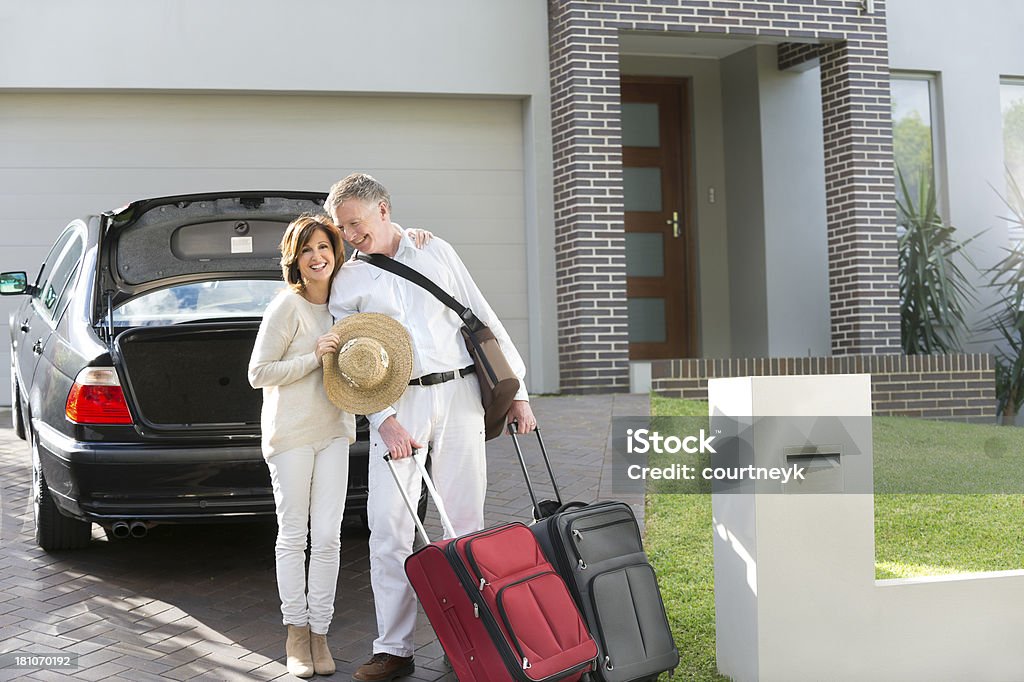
[0,395,648,682]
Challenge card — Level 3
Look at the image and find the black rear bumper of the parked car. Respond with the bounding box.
[34,423,367,524]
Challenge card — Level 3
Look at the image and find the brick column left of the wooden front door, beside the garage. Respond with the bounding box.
[550,1,629,393]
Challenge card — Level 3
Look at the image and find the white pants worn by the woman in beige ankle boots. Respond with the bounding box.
[267,438,348,635]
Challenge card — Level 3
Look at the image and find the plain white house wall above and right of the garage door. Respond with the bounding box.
[0,0,558,392]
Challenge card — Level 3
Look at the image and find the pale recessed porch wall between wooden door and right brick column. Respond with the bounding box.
[722,45,830,357]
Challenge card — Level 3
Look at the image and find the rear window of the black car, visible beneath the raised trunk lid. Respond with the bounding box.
[114,280,285,327]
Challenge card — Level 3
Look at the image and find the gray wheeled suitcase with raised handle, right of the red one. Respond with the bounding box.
[509,428,679,682]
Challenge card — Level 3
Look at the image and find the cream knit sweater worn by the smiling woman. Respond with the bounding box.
[249,289,355,459]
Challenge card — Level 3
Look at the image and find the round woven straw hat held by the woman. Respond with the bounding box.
[322,312,413,415]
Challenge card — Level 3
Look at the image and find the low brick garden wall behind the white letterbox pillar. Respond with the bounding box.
[651,353,995,423]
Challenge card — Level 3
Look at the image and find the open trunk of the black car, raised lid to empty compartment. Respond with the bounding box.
[92,191,325,440]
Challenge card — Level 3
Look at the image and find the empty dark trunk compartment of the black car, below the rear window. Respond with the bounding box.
[114,319,263,437]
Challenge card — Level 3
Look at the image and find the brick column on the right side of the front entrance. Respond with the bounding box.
[819,35,901,355]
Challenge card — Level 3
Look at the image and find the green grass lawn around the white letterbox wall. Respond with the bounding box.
[645,396,1024,680]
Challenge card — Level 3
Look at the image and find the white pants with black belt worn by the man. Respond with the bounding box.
[367,375,487,656]
